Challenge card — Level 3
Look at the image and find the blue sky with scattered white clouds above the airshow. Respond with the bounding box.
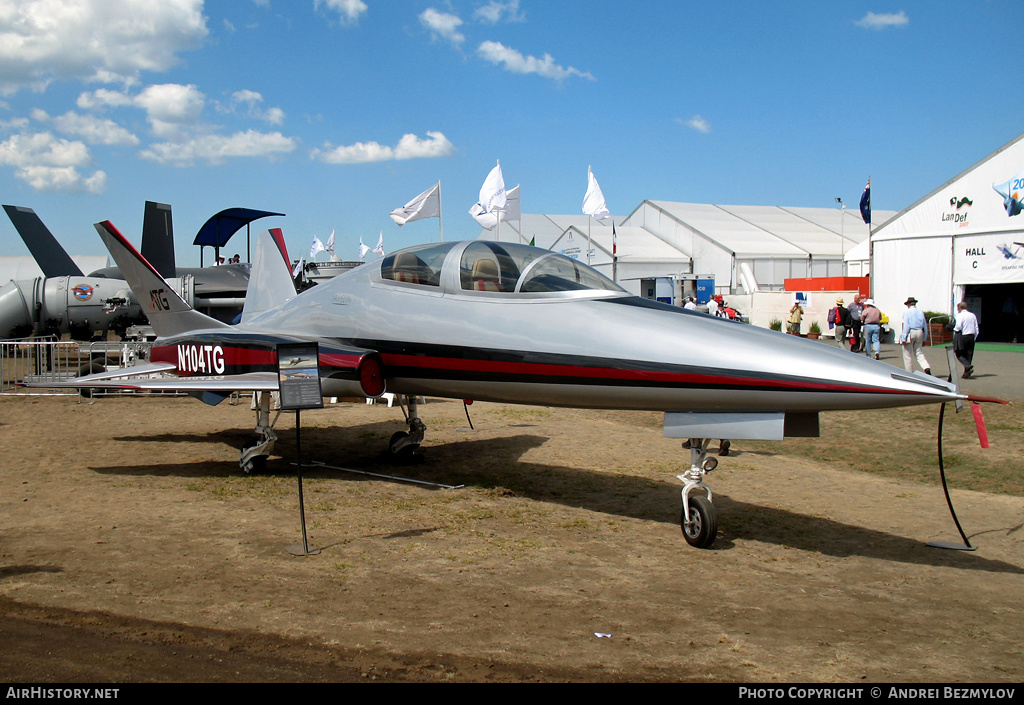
[0,0,1024,264]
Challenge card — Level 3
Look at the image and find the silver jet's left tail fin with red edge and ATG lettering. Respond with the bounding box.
[95,220,230,338]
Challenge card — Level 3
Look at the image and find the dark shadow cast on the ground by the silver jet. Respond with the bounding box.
[92,422,1024,574]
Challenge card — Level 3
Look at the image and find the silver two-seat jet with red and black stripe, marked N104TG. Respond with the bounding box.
[32,221,991,547]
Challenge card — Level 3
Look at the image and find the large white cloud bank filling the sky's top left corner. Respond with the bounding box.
[0,0,208,93]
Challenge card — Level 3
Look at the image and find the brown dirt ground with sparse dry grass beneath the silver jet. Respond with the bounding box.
[0,397,1024,682]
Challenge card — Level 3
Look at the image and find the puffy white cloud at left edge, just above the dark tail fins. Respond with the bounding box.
[0,132,106,194]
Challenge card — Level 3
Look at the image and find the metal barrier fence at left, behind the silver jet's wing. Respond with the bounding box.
[0,337,159,396]
